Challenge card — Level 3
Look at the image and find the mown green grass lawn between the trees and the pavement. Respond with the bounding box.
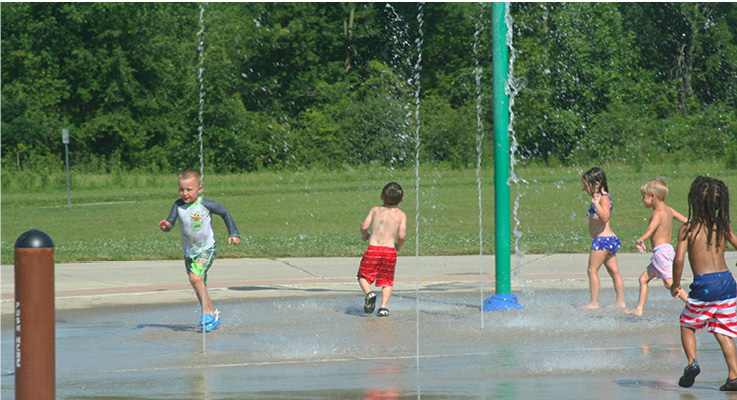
[0,164,737,264]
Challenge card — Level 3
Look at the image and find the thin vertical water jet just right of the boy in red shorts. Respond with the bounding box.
[411,3,424,374]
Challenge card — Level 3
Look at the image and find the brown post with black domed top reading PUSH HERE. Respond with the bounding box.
[15,229,56,400]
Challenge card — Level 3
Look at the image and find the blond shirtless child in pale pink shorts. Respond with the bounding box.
[624,179,687,317]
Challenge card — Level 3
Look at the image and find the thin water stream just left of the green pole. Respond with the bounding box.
[473,3,485,329]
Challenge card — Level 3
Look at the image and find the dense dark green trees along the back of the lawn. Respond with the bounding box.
[2,3,737,172]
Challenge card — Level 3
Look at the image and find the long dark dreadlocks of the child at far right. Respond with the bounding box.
[683,176,730,249]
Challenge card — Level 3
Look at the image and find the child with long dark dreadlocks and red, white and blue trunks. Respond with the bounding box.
[670,176,737,391]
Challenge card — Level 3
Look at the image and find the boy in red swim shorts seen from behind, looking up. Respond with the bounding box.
[358,182,407,317]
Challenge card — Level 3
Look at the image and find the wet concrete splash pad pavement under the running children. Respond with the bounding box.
[1,254,737,400]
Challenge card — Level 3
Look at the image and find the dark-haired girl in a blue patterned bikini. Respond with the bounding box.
[581,167,625,310]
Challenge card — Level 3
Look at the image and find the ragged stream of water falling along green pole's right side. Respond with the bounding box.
[504,3,529,283]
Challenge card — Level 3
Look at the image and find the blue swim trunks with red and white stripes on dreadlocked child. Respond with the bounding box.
[680,271,737,338]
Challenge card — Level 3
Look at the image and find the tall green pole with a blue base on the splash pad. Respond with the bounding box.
[483,3,523,311]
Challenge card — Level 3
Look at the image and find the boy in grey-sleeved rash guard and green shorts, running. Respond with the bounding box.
[159,169,241,331]
